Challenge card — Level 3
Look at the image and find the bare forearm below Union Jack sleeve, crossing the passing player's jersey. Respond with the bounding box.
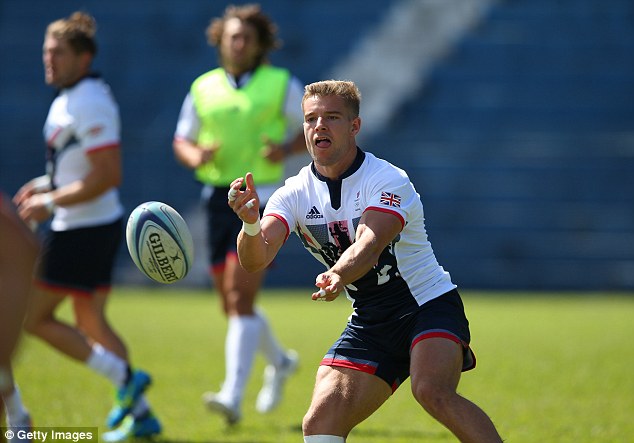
[313,210,403,301]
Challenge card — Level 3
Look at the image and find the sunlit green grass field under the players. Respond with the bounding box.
[9,286,634,443]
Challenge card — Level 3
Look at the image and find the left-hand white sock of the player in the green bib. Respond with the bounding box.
[221,315,262,405]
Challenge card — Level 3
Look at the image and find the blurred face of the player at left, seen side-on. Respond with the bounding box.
[42,36,91,88]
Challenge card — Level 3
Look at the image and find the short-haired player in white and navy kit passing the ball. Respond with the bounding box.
[228,80,502,443]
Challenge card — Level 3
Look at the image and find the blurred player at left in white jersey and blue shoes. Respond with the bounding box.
[7,12,160,441]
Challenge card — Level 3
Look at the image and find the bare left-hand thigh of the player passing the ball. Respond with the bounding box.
[304,366,392,436]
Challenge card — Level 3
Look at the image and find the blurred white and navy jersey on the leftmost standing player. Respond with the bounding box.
[44,77,123,231]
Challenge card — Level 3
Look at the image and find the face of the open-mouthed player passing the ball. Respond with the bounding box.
[302,95,361,178]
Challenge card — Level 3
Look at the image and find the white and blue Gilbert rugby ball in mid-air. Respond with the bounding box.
[126,201,194,284]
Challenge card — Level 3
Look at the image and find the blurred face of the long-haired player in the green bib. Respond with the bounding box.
[220,18,260,75]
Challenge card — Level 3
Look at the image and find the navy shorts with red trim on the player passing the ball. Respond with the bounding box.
[321,289,475,391]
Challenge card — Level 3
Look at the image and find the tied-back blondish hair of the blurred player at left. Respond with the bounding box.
[46,11,97,55]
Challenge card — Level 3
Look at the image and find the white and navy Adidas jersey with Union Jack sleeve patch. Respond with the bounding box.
[264,150,456,319]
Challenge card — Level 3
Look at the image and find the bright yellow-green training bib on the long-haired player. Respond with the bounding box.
[191,65,290,186]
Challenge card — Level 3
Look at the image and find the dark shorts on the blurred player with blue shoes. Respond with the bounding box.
[38,219,123,295]
